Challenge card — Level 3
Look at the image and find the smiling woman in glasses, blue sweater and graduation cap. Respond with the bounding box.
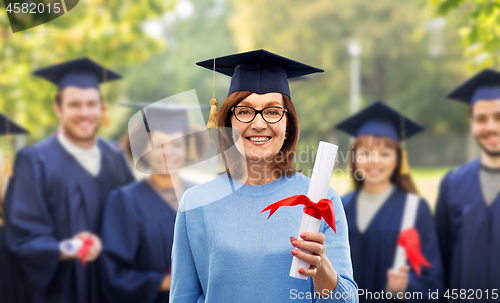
[170,50,356,303]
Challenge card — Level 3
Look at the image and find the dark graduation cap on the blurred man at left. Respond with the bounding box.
[33,57,122,91]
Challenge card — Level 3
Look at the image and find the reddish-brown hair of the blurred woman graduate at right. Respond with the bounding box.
[349,135,418,194]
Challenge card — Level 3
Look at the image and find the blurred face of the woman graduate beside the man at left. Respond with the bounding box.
[144,131,187,174]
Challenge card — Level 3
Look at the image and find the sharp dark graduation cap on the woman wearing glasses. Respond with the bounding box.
[196,49,324,97]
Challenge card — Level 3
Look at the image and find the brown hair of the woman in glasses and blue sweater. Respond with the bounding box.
[217,91,300,176]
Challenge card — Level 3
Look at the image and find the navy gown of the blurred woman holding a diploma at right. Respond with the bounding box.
[342,189,443,302]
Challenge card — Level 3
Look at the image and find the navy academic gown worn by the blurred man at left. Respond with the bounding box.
[5,136,133,303]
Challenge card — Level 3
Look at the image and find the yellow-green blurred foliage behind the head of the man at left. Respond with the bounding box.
[0,0,175,140]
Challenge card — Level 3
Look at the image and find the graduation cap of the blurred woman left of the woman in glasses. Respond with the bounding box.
[120,102,210,133]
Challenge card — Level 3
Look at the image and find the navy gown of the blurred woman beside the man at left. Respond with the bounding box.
[101,180,193,303]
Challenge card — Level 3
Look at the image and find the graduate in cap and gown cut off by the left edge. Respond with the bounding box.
[0,114,28,303]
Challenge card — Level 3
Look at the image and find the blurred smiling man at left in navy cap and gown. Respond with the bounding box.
[5,58,134,303]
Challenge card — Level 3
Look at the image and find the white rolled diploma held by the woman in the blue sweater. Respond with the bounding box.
[290,141,339,280]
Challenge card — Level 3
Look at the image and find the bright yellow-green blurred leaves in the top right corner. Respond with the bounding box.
[429,0,500,73]
